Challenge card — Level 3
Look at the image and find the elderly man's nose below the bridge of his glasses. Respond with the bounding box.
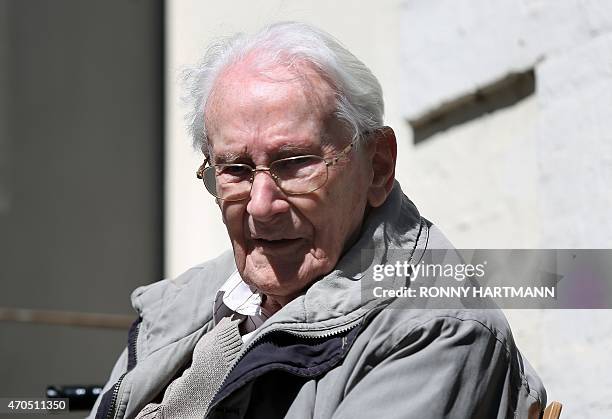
[246,172,289,221]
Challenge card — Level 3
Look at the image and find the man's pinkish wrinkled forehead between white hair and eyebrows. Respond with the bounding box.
[205,60,344,157]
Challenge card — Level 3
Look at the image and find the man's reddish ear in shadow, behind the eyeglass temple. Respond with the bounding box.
[368,127,397,207]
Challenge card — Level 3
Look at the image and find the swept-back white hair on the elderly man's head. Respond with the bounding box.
[184,22,384,156]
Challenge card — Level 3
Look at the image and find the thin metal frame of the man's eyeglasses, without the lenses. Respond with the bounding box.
[196,138,358,202]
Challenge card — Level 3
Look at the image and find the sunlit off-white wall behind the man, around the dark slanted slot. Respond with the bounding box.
[166,0,612,418]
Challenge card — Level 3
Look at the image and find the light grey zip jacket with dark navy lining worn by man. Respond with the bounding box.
[86,183,546,419]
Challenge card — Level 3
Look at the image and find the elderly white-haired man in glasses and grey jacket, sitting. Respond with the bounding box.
[92,23,546,418]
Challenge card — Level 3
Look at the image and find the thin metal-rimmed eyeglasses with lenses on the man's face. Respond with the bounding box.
[196,141,355,201]
